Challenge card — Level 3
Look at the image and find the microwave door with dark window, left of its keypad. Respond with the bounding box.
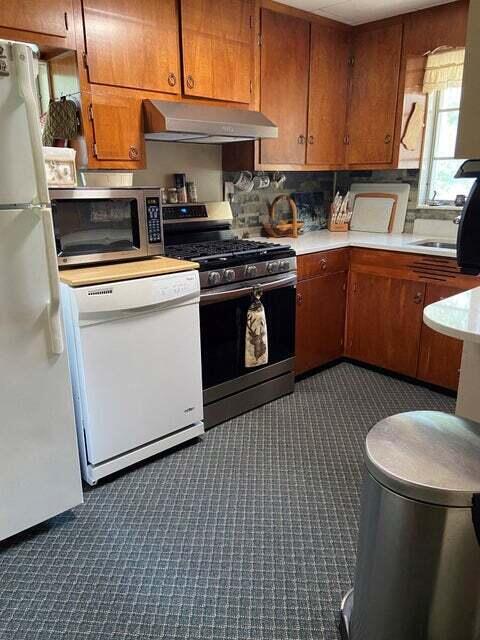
[51,189,148,266]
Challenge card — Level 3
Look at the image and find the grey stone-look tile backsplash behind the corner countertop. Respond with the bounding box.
[223,169,458,236]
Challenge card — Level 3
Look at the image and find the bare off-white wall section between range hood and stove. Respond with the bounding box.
[133,142,223,202]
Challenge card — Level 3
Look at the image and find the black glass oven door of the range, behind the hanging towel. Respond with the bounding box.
[200,273,297,392]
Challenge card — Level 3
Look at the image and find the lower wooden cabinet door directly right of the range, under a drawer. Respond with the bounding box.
[295,272,347,374]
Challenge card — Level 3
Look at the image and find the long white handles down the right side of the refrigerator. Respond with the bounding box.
[13,44,64,355]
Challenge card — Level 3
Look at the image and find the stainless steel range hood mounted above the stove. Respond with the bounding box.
[143,100,278,144]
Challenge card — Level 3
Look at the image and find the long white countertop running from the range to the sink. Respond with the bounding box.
[248,229,456,258]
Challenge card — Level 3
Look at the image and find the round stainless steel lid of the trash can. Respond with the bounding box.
[365,411,480,507]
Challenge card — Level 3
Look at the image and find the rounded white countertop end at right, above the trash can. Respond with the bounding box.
[423,287,480,343]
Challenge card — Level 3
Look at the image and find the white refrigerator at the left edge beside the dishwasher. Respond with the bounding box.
[0,40,82,540]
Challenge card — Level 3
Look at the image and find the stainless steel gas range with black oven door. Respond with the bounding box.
[163,203,297,427]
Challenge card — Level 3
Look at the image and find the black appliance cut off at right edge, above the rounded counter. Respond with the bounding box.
[455,160,480,275]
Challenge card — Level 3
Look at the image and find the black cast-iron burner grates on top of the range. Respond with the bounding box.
[166,238,290,262]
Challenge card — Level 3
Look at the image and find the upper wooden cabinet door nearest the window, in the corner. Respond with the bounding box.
[347,24,403,165]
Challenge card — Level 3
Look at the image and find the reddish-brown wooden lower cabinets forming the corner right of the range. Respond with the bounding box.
[295,248,480,390]
